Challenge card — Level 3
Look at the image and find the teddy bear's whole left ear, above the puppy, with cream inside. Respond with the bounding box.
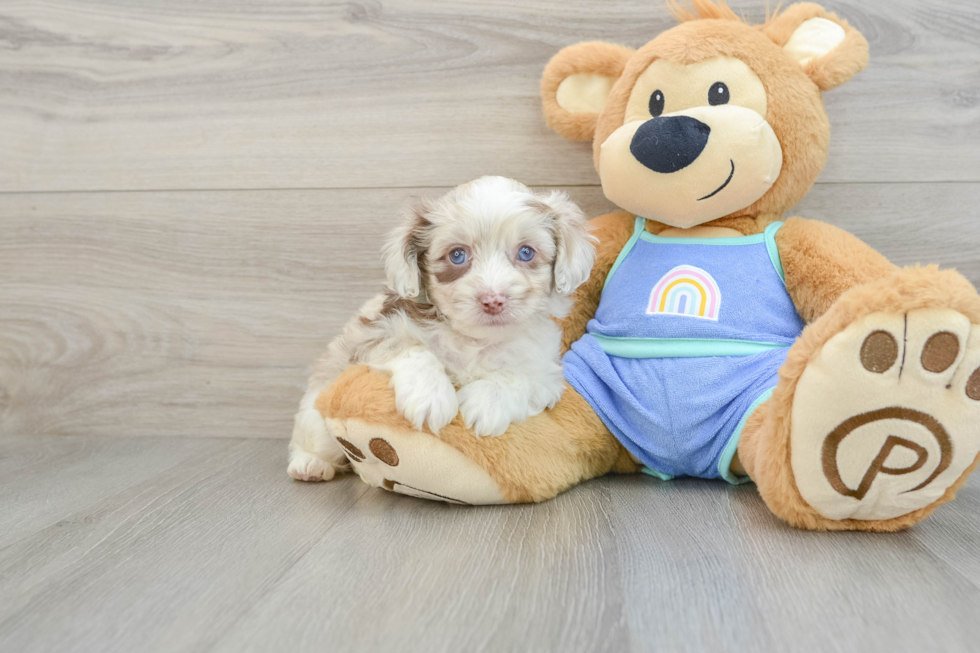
[541,41,633,141]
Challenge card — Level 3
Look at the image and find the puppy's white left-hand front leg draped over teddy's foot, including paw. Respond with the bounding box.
[388,347,459,434]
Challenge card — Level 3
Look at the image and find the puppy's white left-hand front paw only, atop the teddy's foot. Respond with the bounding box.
[391,366,459,434]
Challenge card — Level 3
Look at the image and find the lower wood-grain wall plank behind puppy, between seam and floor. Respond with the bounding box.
[0,183,980,438]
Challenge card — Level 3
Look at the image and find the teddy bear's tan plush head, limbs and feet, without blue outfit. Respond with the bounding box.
[317,0,980,531]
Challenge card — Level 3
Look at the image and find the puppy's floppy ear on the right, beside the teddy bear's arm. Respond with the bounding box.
[535,190,596,295]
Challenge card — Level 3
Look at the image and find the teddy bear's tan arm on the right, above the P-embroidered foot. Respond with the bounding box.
[776,218,897,324]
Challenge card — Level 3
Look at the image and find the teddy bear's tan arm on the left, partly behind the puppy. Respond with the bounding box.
[561,211,635,354]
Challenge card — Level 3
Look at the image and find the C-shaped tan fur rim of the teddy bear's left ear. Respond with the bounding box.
[541,41,633,141]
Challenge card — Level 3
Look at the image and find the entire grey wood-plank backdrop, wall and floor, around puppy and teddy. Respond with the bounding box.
[0,0,980,653]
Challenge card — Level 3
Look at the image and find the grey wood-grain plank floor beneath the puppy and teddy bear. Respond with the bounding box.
[0,437,980,653]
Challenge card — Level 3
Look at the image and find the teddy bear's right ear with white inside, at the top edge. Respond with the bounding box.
[762,2,868,91]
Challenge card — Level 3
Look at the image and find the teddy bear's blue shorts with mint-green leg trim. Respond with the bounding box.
[564,335,789,483]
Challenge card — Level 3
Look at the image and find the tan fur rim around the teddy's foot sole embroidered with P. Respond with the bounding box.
[738,266,980,531]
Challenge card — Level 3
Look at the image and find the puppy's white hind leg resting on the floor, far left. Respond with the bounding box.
[287,387,350,481]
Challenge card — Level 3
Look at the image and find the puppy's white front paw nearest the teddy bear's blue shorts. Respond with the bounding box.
[456,373,531,436]
